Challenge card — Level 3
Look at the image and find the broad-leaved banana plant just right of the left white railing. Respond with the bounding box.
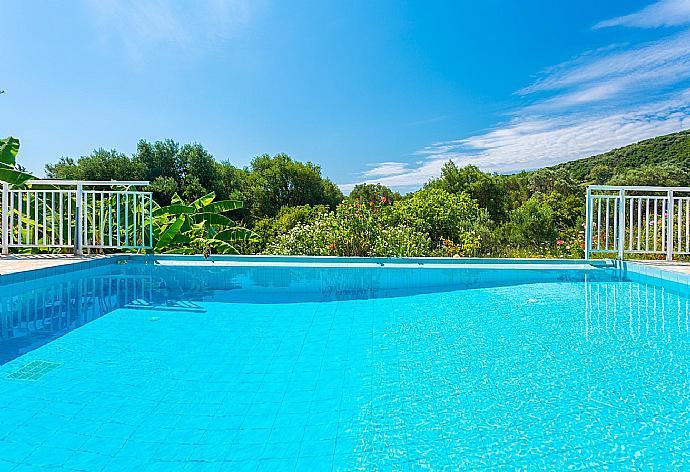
[152,192,258,256]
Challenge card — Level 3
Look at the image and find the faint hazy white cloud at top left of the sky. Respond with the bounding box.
[84,0,264,59]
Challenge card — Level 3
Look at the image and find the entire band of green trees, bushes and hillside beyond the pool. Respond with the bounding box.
[46,132,690,257]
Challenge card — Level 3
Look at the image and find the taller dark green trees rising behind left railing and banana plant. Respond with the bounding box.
[46,139,343,216]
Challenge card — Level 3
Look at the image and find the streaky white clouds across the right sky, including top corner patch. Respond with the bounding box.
[343,0,690,190]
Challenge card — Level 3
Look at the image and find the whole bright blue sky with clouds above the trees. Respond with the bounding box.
[0,0,690,191]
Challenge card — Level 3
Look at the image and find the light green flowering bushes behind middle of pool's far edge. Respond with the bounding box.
[265,189,486,257]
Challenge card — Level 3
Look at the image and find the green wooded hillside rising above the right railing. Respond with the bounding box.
[551,130,690,183]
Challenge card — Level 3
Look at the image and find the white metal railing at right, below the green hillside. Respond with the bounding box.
[585,185,690,261]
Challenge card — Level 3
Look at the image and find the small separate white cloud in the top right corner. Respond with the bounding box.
[594,0,690,28]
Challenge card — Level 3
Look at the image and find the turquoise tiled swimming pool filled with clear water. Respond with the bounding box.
[0,257,690,471]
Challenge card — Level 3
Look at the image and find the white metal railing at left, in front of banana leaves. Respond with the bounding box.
[1,180,153,254]
